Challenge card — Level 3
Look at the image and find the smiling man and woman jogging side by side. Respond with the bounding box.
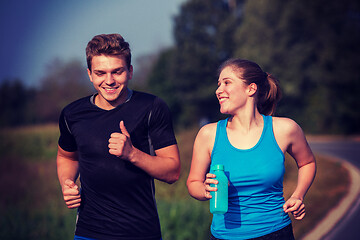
[57,34,316,240]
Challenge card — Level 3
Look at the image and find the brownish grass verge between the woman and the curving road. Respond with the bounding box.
[284,156,350,239]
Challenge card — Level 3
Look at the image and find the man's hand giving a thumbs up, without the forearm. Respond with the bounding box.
[109,121,133,160]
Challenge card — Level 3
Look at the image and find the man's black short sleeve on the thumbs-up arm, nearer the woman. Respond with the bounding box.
[149,98,176,150]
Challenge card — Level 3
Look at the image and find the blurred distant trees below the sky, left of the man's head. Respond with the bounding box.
[0,60,92,128]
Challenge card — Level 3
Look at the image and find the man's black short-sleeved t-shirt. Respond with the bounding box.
[59,91,176,240]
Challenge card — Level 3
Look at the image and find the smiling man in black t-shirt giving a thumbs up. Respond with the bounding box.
[57,34,180,240]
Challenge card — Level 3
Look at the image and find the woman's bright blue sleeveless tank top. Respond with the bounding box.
[211,115,291,239]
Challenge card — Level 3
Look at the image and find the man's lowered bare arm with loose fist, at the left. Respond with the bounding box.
[56,146,81,208]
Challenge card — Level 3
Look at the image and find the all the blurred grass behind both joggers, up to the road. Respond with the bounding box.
[0,125,349,240]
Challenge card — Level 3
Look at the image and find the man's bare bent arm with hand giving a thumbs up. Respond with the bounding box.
[109,121,180,183]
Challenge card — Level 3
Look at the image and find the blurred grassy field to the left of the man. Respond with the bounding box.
[0,125,76,240]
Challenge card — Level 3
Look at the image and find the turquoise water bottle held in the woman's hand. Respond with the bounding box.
[210,164,228,214]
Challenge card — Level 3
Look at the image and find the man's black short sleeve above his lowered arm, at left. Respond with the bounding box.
[58,110,77,152]
